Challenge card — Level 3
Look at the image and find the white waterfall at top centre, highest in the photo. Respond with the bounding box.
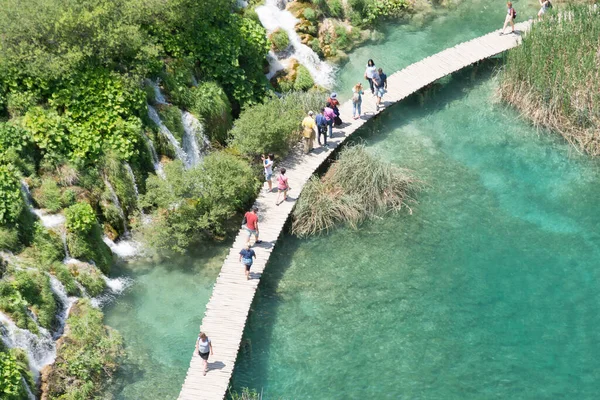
[255,0,334,88]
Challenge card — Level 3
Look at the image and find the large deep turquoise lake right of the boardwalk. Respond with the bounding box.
[234,67,600,400]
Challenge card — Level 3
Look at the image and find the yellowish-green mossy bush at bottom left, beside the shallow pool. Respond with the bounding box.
[47,299,123,400]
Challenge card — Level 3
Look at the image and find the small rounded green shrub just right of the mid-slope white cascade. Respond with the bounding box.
[189,82,232,144]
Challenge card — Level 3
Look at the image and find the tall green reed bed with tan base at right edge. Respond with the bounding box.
[500,5,600,156]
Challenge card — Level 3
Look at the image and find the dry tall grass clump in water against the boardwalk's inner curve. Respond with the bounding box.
[292,145,418,237]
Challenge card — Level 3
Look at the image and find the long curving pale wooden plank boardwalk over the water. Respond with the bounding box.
[179,22,529,400]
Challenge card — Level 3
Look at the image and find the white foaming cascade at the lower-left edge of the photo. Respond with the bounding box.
[0,312,56,379]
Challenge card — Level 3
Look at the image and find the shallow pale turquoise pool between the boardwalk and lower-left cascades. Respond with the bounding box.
[103,243,230,400]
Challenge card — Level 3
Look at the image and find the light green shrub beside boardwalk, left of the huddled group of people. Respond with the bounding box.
[231,92,326,156]
